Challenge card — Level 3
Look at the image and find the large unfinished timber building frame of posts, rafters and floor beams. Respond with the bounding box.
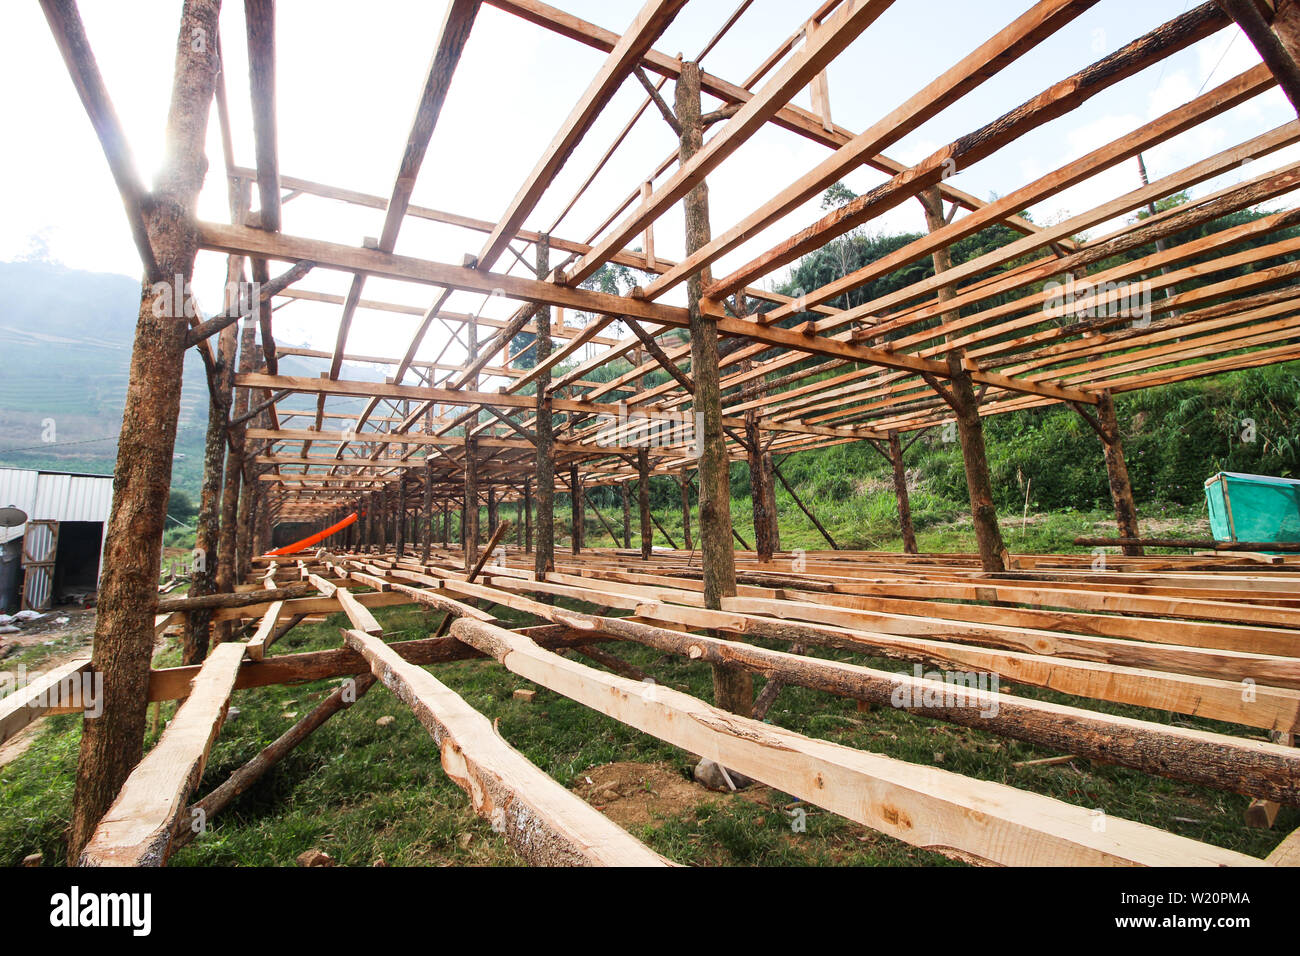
[27,0,1300,865]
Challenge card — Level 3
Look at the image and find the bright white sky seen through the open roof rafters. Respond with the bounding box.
[0,0,1296,390]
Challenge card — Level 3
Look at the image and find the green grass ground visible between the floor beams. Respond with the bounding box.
[0,606,1300,866]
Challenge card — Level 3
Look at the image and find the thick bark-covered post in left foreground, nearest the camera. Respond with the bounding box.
[63,0,220,860]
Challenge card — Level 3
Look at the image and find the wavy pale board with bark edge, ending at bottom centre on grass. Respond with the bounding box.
[345,631,667,866]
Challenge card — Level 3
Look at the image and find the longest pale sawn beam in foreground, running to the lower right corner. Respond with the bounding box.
[451,620,1265,866]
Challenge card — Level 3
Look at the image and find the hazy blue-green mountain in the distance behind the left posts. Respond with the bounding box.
[0,261,384,492]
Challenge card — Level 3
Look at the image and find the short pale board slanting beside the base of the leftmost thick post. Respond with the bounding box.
[78,644,244,866]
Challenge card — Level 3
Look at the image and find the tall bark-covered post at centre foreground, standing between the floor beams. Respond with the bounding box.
[675,62,754,714]
